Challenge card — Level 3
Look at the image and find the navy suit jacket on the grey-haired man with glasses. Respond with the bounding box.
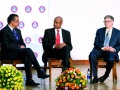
[93,27,120,61]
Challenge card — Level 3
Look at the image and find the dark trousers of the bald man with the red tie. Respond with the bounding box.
[42,46,70,68]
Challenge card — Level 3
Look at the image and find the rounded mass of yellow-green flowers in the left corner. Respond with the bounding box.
[0,66,23,90]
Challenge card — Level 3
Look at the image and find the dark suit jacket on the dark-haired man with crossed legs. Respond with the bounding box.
[0,25,26,59]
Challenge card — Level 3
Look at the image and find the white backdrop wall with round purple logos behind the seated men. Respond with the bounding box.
[0,0,120,65]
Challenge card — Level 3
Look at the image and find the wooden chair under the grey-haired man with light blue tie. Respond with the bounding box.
[90,58,117,83]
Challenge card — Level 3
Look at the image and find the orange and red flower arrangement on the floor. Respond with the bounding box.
[55,67,87,90]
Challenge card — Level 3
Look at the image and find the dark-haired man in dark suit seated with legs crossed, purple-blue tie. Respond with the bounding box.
[0,14,49,86]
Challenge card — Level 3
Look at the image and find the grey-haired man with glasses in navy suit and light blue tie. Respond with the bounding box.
[89,15,120,83]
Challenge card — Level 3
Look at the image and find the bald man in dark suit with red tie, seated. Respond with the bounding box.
[42,16,72,71]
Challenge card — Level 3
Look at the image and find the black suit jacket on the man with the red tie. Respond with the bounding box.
[43,28,72,51]
